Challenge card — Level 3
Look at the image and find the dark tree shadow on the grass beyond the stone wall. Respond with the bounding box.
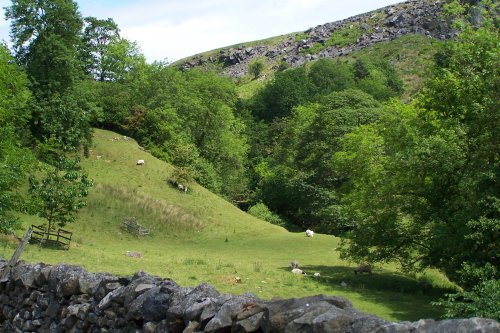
[281,265,452,321]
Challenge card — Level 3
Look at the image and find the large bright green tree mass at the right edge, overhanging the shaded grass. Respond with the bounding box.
[335,9,500,300]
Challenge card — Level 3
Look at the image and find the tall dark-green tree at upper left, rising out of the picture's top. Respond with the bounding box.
[6,0,91,150]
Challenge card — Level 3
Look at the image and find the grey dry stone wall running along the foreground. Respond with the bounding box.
[0,261,500,333]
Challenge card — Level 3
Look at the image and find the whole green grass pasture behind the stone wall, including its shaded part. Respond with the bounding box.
[0,130,452,320]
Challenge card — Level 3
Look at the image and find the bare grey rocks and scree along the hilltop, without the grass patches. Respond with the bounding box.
[177,0,454,77]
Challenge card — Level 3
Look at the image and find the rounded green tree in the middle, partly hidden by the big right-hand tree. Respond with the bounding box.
[260,89,381,233]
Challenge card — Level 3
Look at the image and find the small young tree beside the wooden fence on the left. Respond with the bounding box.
[29,147,92,233]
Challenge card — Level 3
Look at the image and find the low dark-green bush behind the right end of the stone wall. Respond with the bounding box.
[434,280,500,320]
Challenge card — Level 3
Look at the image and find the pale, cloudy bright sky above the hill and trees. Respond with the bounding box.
[0,0,401,62]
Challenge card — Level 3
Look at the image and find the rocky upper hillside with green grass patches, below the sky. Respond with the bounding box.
[174,0,454,79]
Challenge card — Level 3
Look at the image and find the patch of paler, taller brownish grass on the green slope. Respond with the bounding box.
[88,184,205,233]
